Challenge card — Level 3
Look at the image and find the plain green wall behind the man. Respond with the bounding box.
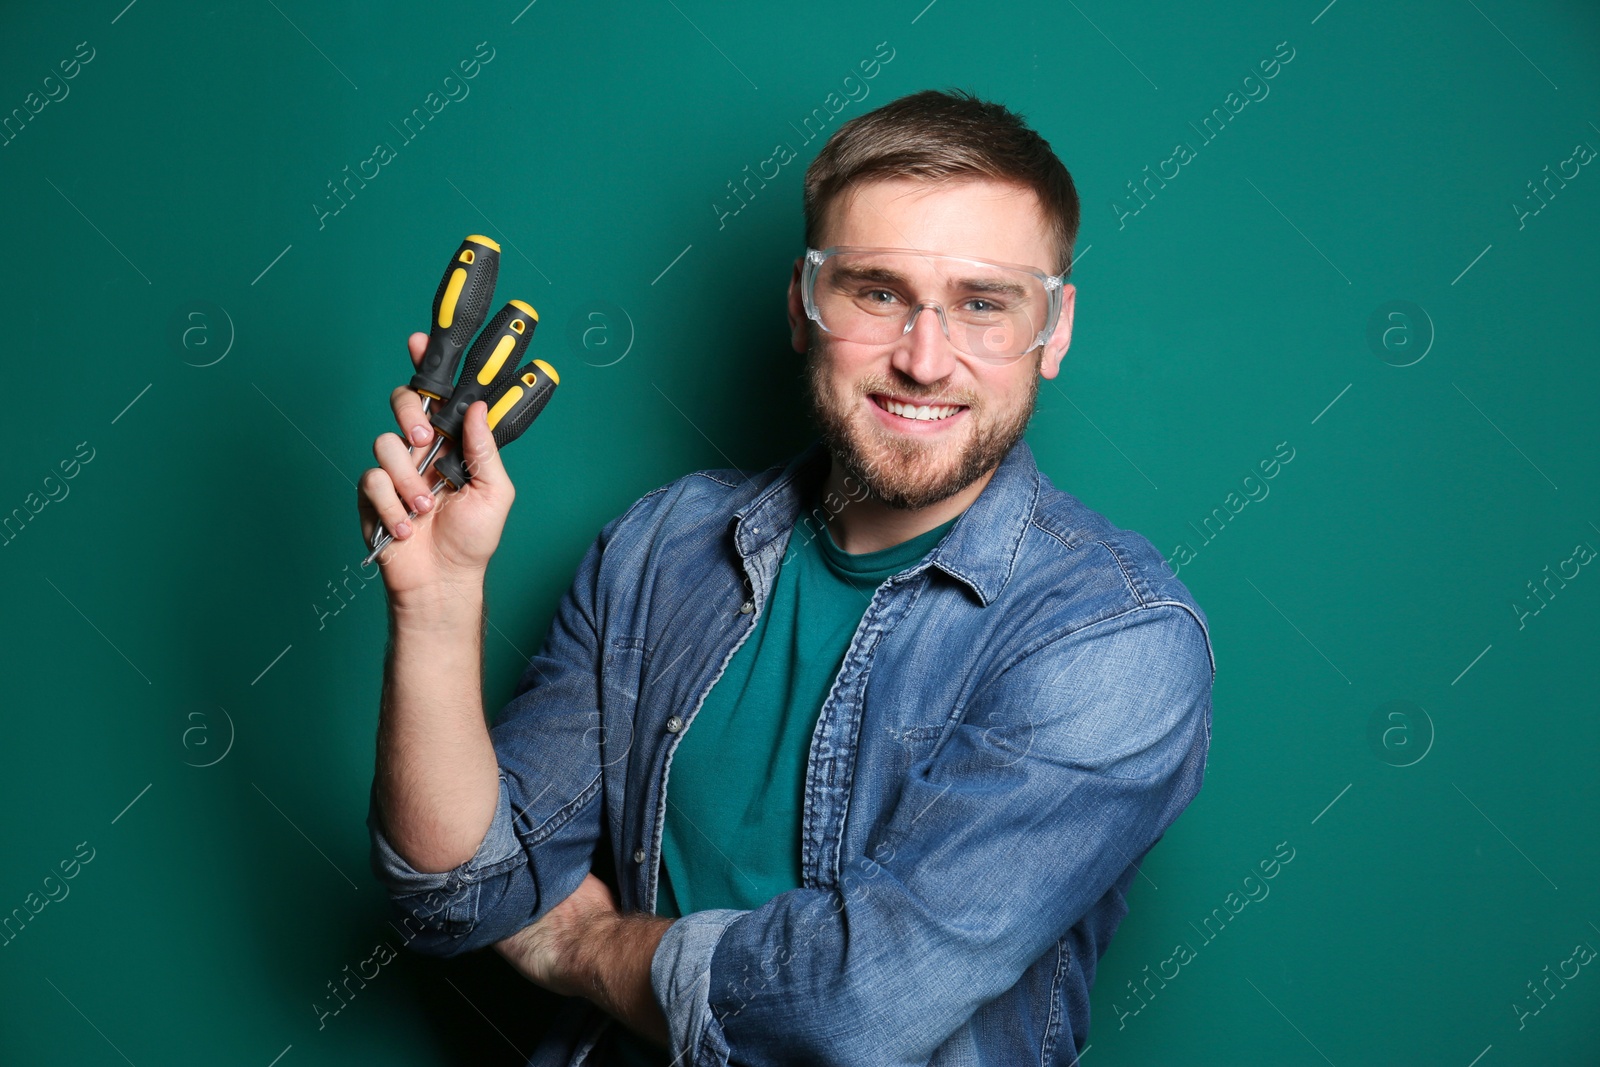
[0,0,1600,1067]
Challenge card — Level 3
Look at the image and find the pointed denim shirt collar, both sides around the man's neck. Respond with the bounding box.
[730,440,1040,606]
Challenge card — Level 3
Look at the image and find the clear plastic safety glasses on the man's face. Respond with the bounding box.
[802,246,1067,363]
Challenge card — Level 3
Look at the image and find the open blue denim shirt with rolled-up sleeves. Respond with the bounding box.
[368,442,1216,1067]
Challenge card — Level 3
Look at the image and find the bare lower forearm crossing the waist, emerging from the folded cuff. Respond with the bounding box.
[494,875,672,1046]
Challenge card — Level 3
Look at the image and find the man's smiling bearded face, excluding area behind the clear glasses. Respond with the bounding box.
[789,178,1075,509]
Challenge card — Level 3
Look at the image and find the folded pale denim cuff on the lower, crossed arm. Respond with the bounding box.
[650,909,747,1064]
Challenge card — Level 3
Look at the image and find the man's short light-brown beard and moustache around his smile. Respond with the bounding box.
[806,334,1043,510]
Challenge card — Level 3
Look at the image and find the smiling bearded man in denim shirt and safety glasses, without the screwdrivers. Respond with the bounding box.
[360,91,1214,1064]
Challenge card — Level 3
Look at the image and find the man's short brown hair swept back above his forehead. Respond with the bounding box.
[805,90,1078,274]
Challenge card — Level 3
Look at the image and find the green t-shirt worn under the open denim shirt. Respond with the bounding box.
[618,512,955,1064]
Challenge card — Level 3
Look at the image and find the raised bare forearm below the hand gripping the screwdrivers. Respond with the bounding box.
[374,576,499,872]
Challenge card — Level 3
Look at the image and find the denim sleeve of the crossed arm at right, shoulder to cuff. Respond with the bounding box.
[651,603,1214,1067]
